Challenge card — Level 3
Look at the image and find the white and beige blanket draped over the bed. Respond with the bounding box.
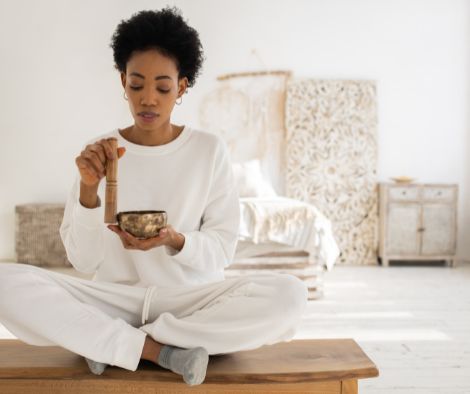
[239,196,339,270]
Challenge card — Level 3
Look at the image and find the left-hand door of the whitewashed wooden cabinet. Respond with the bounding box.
[386,203,421,255]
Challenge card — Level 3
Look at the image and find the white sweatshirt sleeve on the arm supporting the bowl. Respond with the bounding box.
[166,142,240,271]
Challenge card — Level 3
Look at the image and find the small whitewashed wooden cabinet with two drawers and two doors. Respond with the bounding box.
[379,183,458,266]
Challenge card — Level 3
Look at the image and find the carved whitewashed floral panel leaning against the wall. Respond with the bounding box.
[285,79,378,264]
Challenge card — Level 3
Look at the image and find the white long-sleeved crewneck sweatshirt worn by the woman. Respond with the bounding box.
[60,126,240,287]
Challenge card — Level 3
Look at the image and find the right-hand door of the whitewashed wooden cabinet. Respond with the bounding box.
[422,204,455,256]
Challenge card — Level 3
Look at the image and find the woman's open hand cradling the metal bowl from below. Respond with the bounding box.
[108,224,184,251]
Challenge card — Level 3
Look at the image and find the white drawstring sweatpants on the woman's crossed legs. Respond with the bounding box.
[0,263,308,371]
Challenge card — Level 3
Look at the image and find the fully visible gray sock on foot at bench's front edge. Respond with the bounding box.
[157,345,209,386]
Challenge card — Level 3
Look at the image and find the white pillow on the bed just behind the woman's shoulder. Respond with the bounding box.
[232,160,276,197]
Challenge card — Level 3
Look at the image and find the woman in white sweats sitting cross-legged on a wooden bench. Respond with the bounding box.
[0,8,307,385]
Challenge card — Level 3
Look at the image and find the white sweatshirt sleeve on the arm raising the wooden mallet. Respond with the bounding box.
[59,175,104,273]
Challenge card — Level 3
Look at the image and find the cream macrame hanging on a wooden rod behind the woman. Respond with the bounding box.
[199,71,290,195]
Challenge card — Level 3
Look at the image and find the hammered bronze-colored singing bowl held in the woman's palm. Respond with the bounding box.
[117,211,167,239]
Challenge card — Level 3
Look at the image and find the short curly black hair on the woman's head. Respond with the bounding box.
[110,6,204,87]
